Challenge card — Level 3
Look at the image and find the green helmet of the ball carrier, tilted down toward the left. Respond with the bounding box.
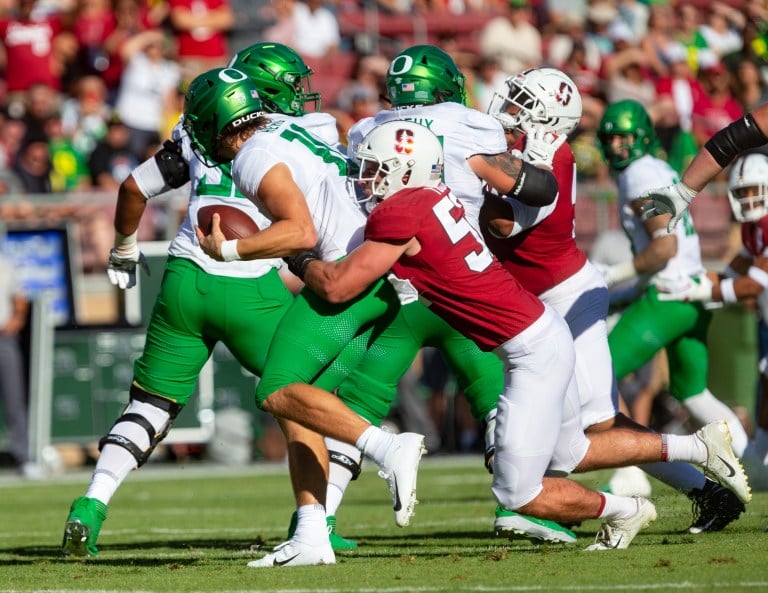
[183,68,264,166]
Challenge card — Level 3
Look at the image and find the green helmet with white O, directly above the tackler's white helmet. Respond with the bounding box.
[386,45,467,107]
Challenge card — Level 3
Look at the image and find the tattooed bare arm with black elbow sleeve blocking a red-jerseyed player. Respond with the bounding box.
[467,152,557,207]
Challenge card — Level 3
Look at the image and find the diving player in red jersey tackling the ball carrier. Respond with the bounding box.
[303,121,750,550]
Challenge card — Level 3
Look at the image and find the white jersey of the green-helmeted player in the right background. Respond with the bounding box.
[616,155,704,286]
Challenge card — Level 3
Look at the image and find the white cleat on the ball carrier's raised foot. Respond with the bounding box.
[379,432,427,527]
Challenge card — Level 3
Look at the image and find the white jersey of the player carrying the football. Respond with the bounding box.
[232,119,365,261]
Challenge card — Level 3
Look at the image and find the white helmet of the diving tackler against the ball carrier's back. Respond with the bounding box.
[355,120,444,201]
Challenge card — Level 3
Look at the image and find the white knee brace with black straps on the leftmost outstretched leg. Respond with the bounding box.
[99,384,182,467]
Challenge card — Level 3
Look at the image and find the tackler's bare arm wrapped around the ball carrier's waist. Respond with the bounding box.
[304,237,421,303]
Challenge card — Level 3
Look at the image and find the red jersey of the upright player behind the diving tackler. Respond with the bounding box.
[481,143,587,295]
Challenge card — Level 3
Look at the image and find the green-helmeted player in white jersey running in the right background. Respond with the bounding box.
[598,100,747,494]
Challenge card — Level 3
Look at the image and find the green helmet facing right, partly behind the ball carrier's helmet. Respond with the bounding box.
[229,43,320,115]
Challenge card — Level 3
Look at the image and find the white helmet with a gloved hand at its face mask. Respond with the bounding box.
[488,68,581,135]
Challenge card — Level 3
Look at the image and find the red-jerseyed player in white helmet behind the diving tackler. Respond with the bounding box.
[480,68,744,542]
